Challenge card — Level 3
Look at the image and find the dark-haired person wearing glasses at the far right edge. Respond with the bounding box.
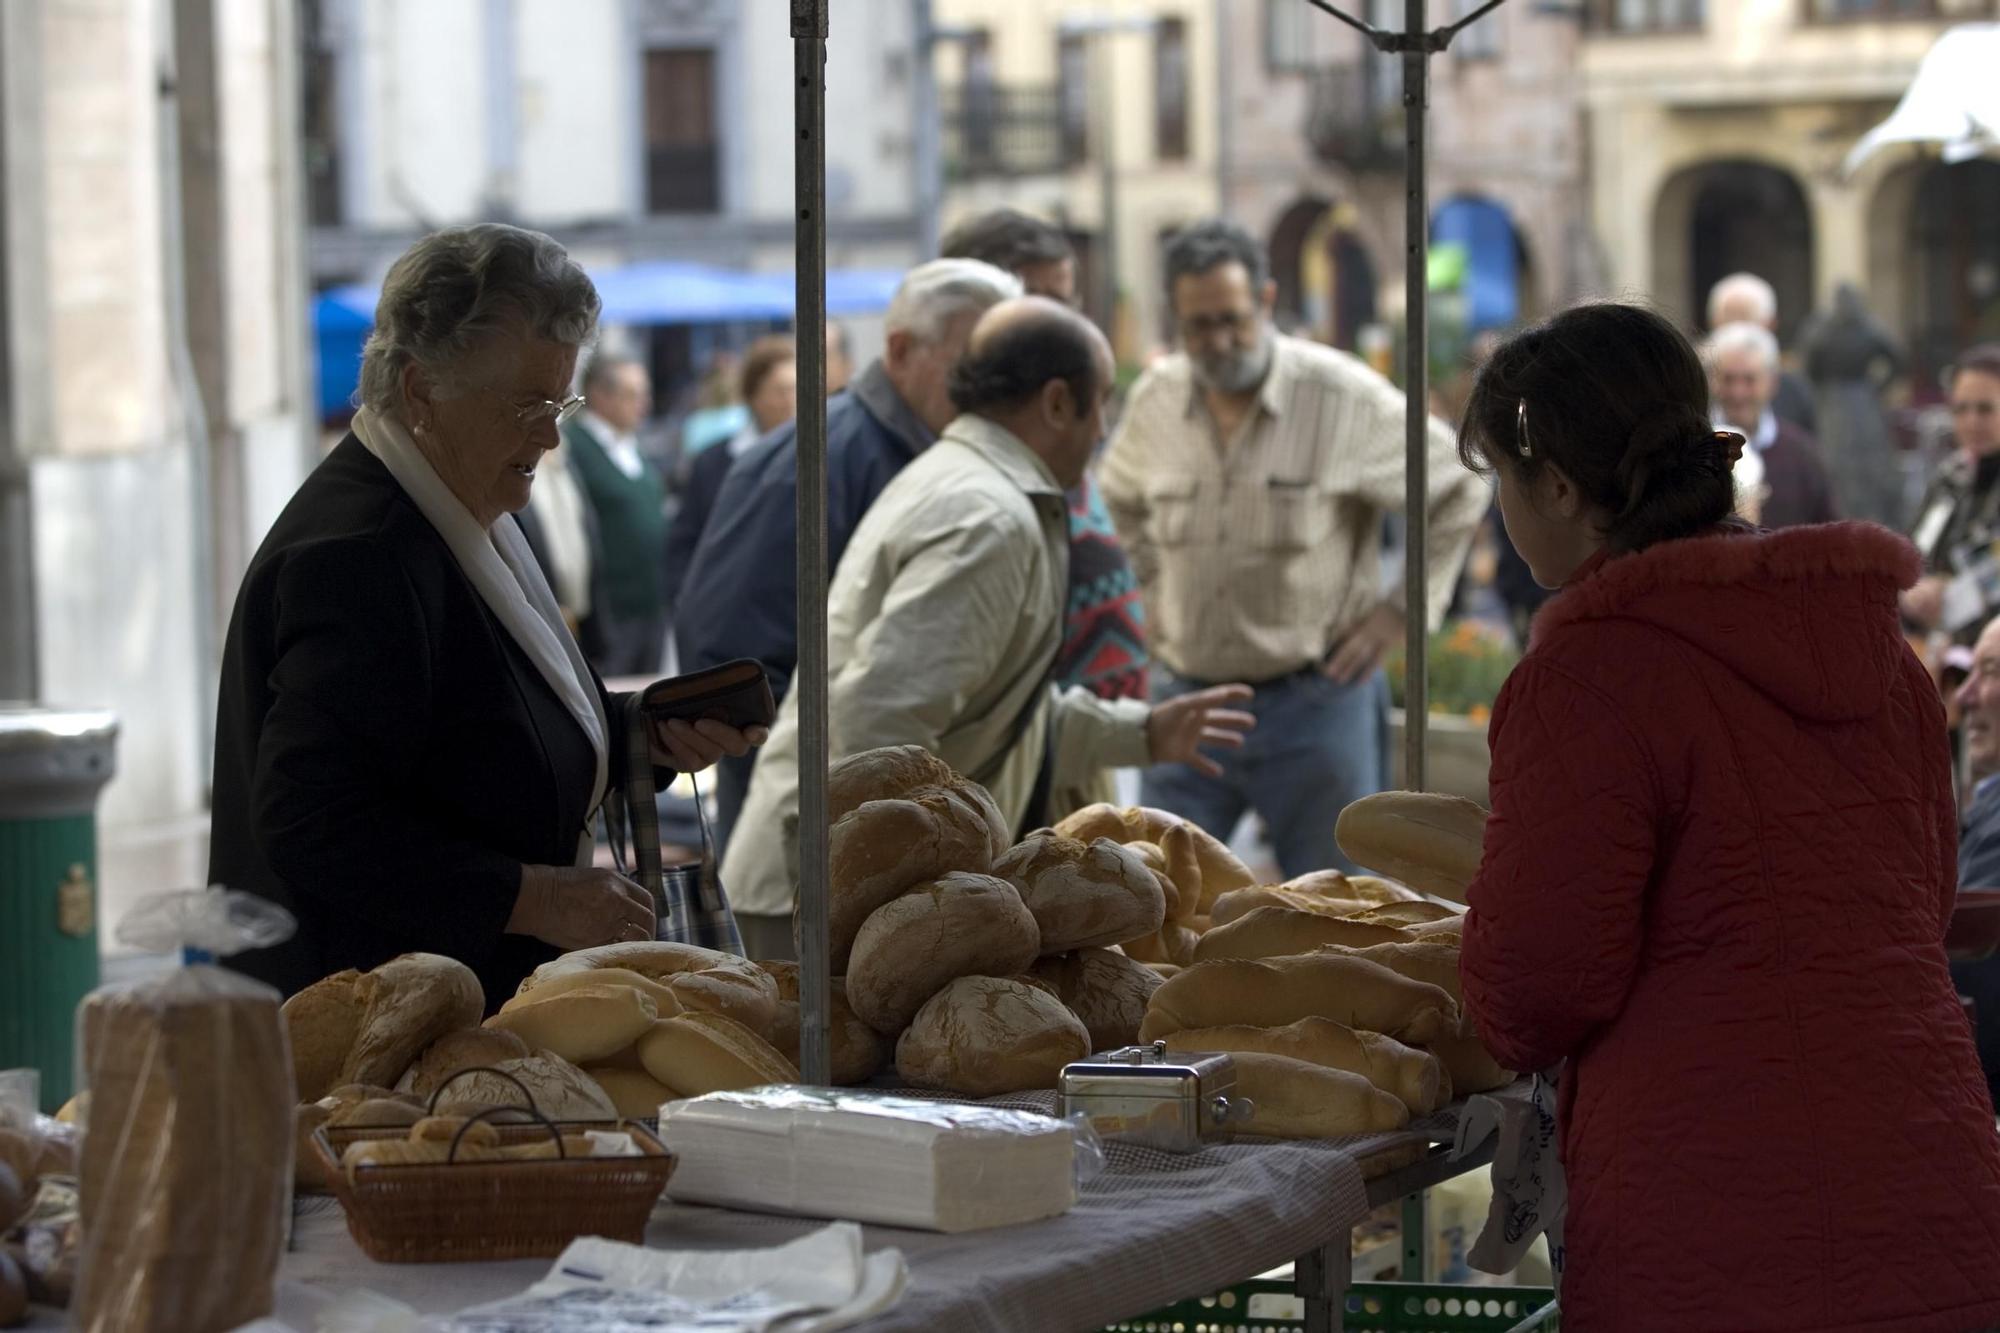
[1902,342,2000,642]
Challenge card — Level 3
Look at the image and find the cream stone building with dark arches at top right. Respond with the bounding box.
[1580,0,2000,382]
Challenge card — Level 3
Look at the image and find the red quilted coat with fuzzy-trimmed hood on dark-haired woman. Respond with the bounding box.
[1462,522,2000,1333]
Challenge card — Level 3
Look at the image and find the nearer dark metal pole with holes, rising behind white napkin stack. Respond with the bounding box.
[792,0,832,1085]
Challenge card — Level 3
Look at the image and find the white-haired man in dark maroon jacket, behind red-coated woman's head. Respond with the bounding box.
[1702,322,1840,528]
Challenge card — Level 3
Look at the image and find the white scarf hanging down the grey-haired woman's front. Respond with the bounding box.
[354,408,610,865]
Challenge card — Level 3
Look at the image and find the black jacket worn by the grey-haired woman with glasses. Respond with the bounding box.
[208,434,622,1011]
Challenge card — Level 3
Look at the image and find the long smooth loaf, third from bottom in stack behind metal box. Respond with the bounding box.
[1140,951,1458,1045]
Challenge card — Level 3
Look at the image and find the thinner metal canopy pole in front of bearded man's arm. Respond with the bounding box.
[1402,0,1430,791]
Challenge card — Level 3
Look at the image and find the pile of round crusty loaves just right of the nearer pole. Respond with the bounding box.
[812,747,1254,1097]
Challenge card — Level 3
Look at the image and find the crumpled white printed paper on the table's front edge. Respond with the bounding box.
[442,1223,908,1333]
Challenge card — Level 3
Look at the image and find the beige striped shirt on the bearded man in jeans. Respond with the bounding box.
[1098,336,1488,683]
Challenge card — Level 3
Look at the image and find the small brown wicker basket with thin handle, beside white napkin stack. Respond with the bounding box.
[312,1064,676,1263]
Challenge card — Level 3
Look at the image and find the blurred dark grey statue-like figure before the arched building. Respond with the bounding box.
[1804,282,1906,530]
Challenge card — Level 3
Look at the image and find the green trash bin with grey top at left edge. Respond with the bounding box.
[0,703,118,1111]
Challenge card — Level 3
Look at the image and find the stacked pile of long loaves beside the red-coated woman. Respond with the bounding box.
[1140,793,1514,1139]
